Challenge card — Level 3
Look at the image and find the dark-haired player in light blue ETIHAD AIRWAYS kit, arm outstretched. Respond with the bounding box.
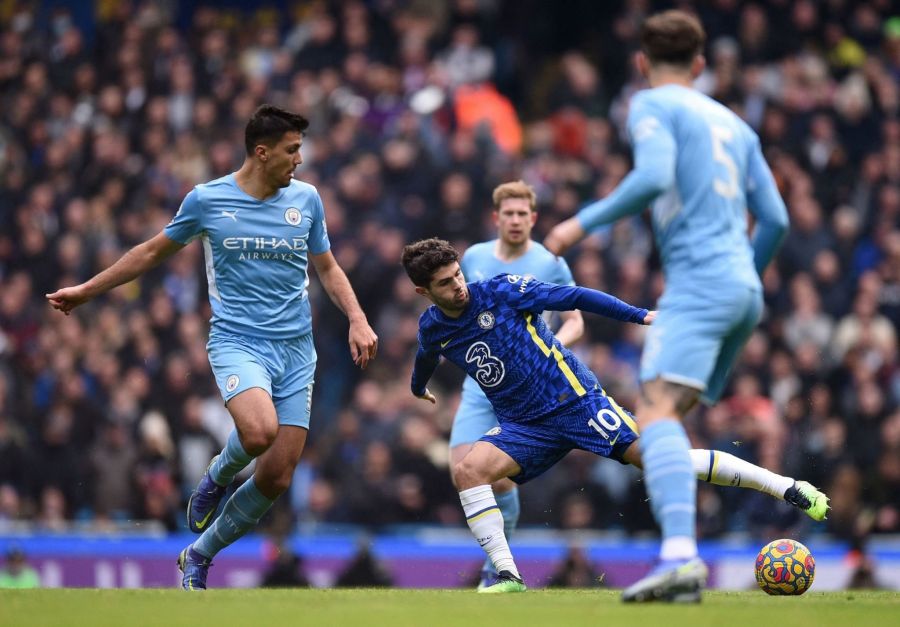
[47,105,378,590]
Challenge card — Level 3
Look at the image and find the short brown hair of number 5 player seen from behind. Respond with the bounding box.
[641,9,706,66]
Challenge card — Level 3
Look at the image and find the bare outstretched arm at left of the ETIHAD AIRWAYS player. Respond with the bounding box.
[46,233,184,316]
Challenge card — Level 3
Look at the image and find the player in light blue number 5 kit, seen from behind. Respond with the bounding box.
[544,10,814,601]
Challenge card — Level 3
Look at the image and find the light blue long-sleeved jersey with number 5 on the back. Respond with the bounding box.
[578,85,787,287]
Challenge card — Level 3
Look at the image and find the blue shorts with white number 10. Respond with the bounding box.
[481,389,638,483]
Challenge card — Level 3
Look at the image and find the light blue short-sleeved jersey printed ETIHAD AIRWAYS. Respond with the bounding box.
[165,174,330,340]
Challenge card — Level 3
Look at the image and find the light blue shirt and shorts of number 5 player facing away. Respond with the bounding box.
[577,84,788,401]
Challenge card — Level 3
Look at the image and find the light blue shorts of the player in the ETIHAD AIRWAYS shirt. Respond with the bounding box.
[206,331,316,429]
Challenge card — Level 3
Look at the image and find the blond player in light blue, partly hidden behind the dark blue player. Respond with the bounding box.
[450,181,584,588]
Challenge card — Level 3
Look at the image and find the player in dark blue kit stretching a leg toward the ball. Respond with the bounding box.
[402,239,826,601]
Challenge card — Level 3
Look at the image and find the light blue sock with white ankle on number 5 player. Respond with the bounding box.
[639,419,697,559]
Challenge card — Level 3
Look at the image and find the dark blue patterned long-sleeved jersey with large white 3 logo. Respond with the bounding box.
[412,274,647,422]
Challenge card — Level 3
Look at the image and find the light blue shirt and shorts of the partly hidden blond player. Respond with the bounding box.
[450,240,575,447]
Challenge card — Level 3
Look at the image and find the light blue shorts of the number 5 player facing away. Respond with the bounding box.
[641,284,763,403]
